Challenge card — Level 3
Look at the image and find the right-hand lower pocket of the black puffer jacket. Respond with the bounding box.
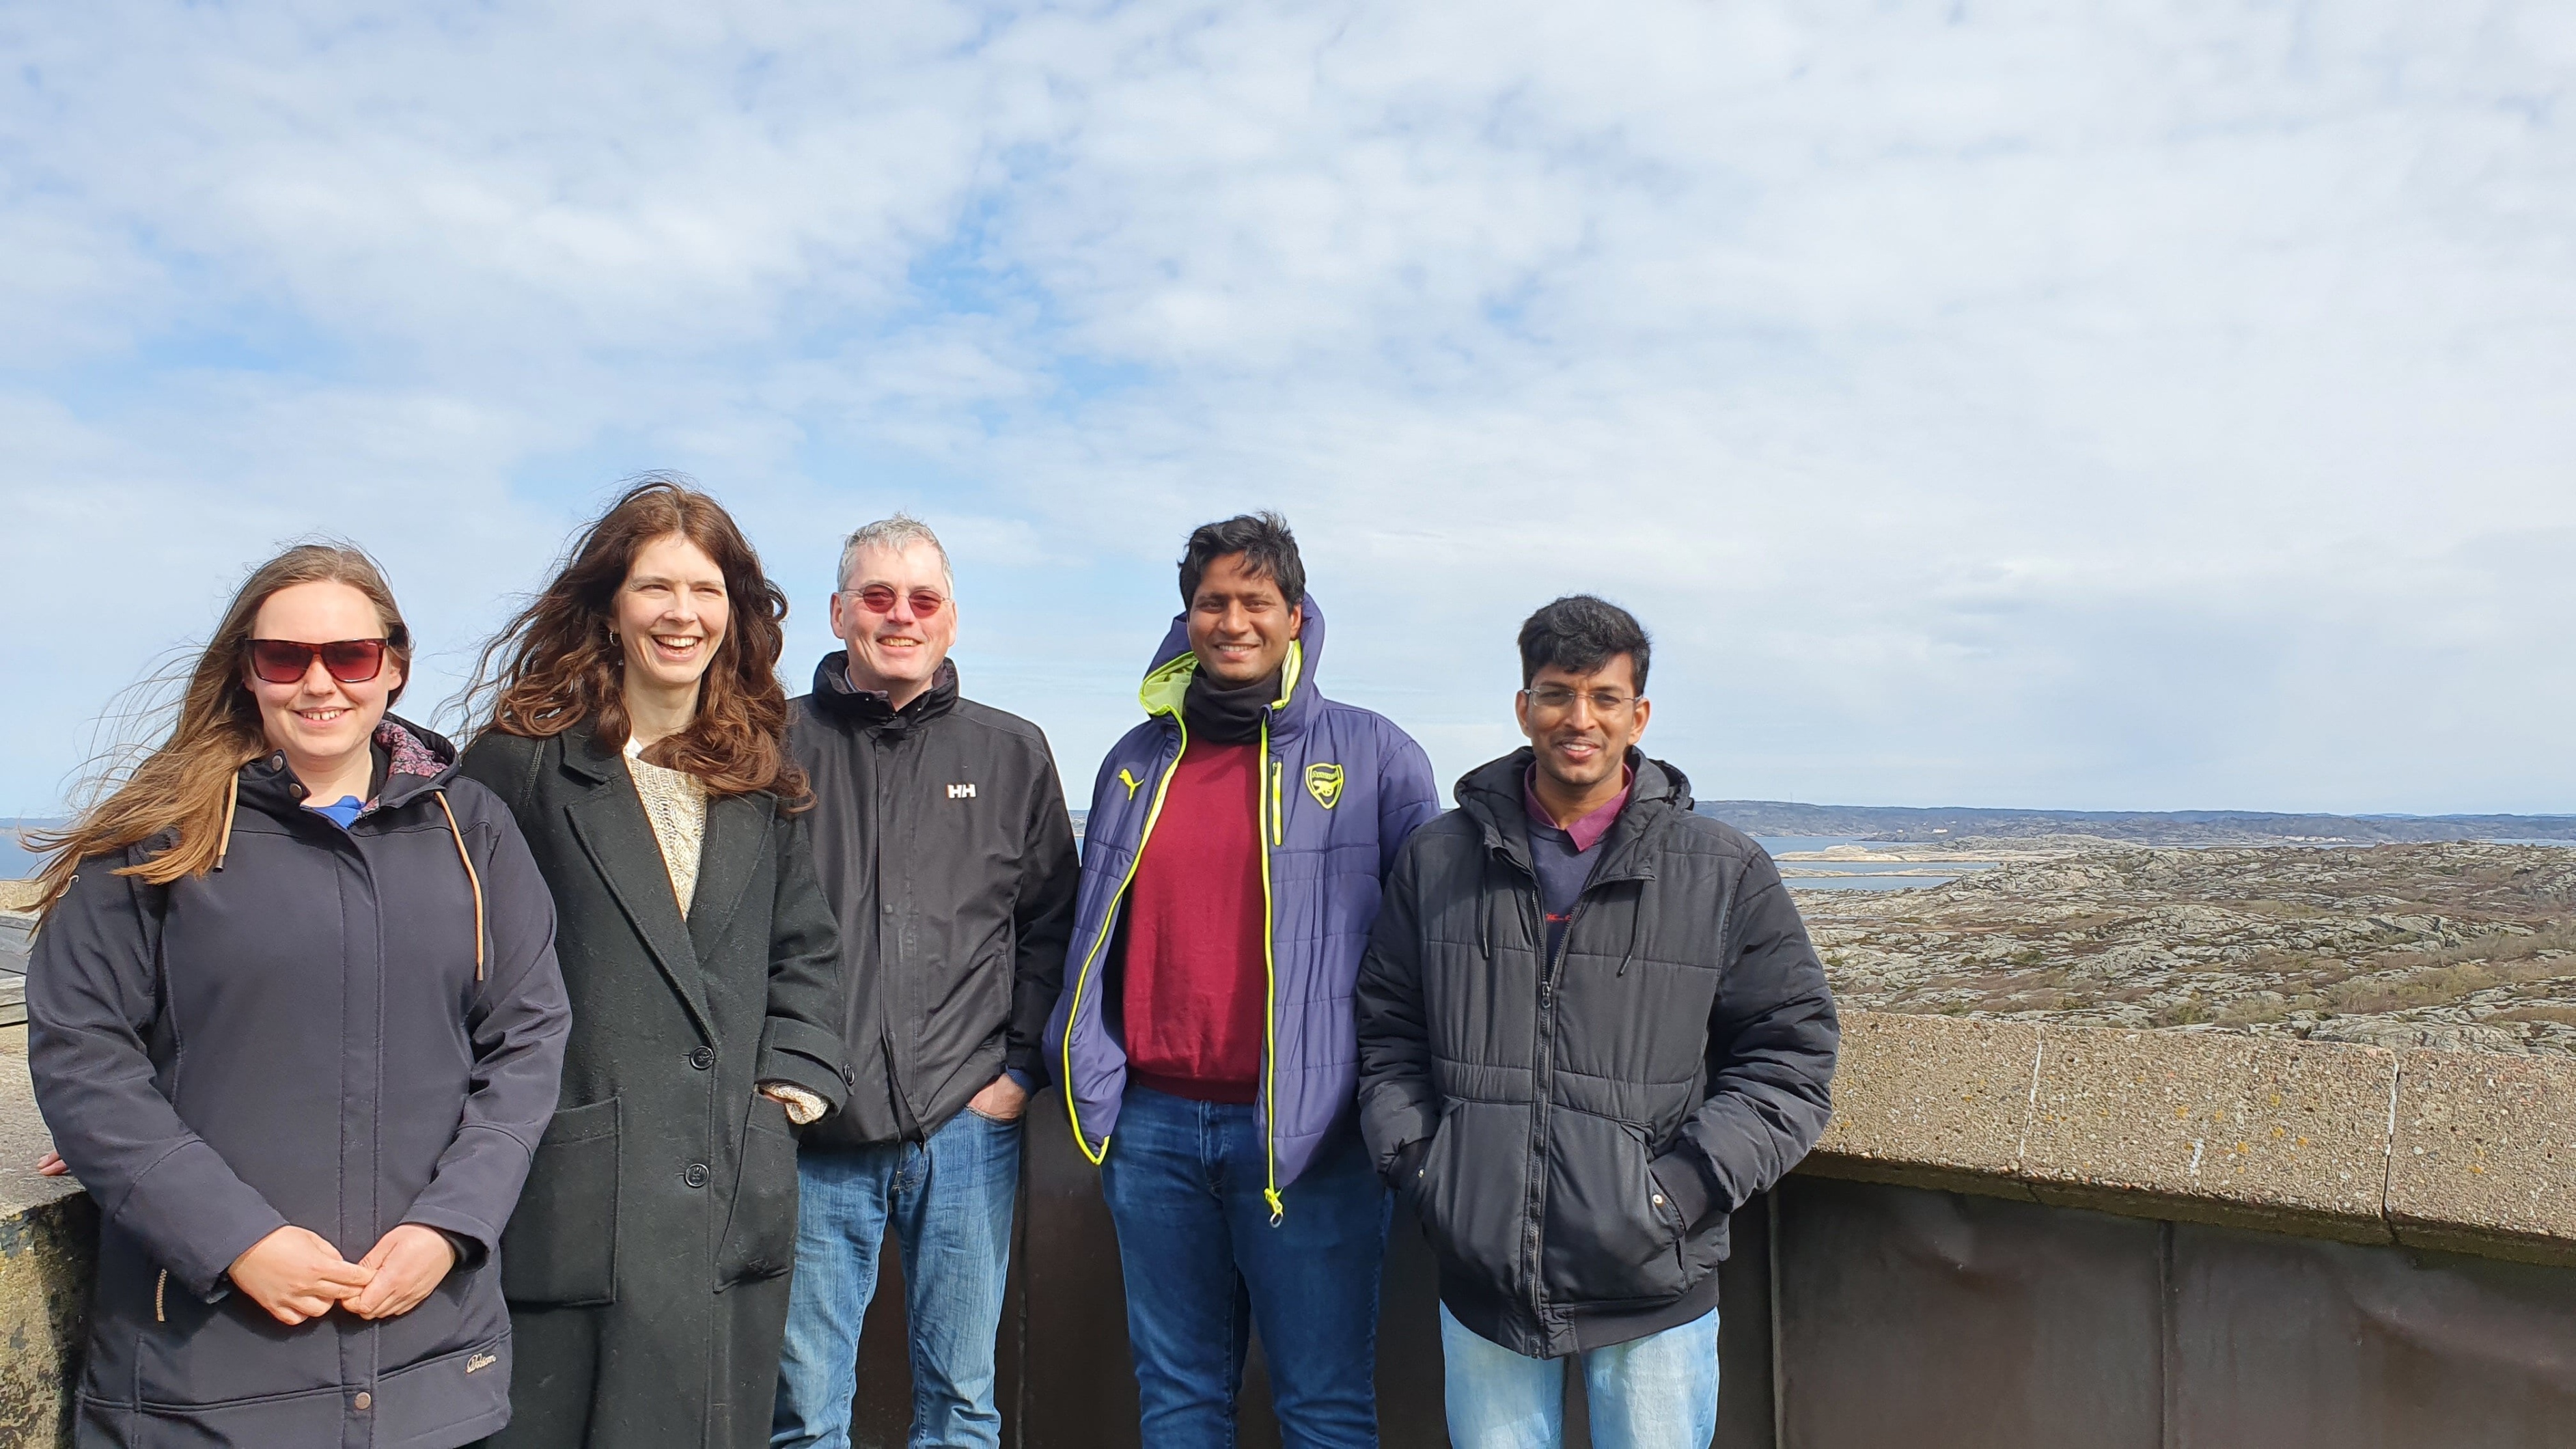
[1540,1106,1690,1305]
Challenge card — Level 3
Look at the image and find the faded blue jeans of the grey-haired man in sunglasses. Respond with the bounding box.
[771,1112,1020,1449]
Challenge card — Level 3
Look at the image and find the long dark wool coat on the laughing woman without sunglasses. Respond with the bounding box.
[467,727,845,1449]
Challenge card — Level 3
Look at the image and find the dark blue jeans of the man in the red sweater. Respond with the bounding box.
[1100,1086,1391,1449]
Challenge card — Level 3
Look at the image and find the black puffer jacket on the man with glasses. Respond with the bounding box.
[1360,750,1839,1359]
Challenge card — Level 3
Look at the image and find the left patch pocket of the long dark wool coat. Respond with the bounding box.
[500,1099,618,1307]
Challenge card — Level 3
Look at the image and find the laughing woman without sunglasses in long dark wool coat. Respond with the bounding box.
[467,477,845,1449]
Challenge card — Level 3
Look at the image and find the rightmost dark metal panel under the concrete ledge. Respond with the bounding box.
[2172,1225,2576,1449]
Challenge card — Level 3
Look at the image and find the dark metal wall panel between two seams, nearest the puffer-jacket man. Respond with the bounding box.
[1775,1178,2164,1449]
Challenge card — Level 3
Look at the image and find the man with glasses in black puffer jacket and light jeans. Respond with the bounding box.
[1357,596,1839,1449]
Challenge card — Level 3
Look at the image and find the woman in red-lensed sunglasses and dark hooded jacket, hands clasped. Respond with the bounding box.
[26,544,567,1449]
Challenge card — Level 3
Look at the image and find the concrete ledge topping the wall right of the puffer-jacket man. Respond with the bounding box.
[1798,1013,2576,1263]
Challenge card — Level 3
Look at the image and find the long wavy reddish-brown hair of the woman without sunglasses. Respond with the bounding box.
[464,474,806,804]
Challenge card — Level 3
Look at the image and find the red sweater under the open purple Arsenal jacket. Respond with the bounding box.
[1123,740,1270,1103]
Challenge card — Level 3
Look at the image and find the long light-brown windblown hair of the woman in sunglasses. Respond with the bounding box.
[28,544,412,910]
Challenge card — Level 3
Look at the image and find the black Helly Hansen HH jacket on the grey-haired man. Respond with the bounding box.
[788,650,1079,1147]
